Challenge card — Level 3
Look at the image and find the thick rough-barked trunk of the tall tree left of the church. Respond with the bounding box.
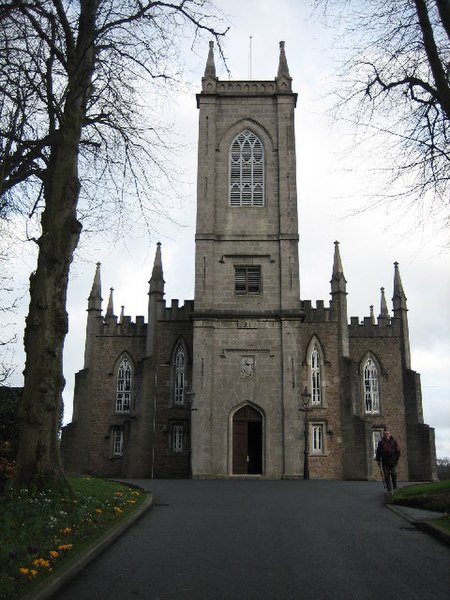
[15,0,98,489]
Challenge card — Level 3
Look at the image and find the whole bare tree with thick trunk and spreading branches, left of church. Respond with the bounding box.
[0,0,224,487]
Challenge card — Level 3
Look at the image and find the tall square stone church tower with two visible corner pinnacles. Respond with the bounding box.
[192,42,302,477]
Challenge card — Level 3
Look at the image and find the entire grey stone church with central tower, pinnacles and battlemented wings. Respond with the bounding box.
[61,42,436,481]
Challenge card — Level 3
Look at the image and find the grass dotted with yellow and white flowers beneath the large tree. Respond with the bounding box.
[0,477,146,600]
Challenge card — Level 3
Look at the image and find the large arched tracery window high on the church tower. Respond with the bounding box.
[230,129,264,206]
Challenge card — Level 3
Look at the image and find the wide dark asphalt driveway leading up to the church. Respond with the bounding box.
[56,480,450,600]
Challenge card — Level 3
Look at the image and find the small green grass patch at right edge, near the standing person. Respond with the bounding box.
[393,479,450,534]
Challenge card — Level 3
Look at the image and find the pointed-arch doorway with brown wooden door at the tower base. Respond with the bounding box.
[233,405,263,475]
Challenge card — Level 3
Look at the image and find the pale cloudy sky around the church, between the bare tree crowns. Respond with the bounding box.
[1,0,450,457]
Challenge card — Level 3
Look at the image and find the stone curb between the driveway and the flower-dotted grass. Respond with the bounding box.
[20,492,153,600]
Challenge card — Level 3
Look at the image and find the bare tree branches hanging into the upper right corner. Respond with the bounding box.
[315,0,450,225]
